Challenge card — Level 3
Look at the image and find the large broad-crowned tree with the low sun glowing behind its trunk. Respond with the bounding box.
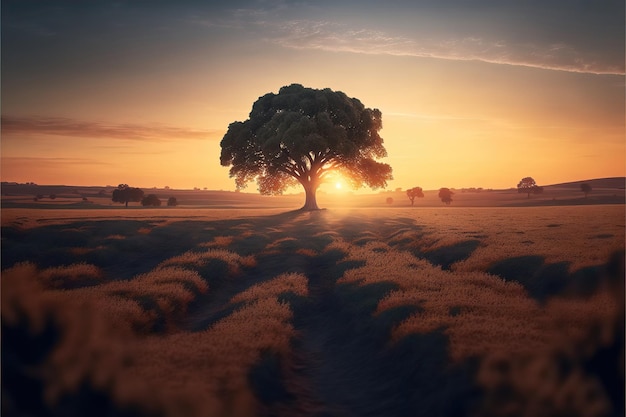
[220,84,392,210]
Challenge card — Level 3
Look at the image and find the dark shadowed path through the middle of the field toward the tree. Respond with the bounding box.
[282,247,424,416]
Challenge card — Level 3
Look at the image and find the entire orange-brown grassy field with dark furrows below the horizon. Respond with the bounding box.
[2,197,625,417]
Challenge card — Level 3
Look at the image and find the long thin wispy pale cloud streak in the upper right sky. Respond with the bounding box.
[267,20,624,75]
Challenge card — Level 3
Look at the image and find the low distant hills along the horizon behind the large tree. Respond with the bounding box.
[2,177,626,209]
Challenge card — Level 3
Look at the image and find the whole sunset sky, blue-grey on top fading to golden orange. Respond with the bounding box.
[1,0,626,191]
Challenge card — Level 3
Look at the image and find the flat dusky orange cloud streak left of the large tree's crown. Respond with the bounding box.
[2,116,223,141]
